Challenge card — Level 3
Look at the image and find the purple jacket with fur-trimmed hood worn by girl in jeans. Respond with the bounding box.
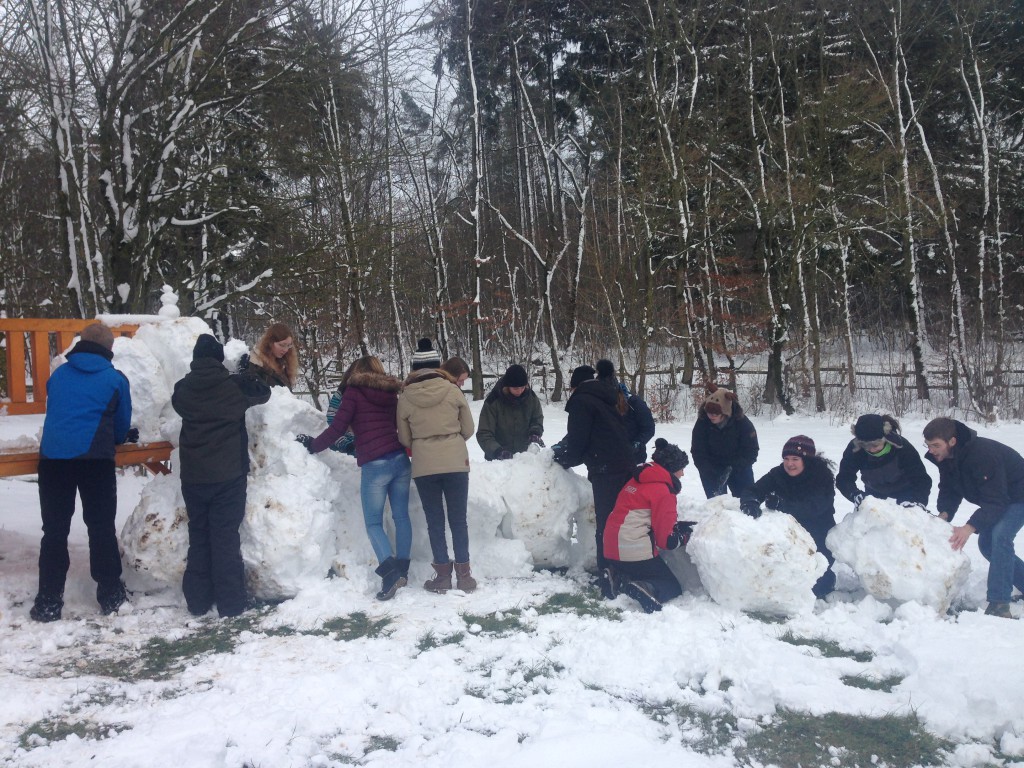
[310,374,406,467]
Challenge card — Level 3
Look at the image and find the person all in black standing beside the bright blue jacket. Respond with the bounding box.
[171,334,270,616]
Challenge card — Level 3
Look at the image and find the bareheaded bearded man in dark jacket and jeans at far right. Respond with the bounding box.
[925,418,1024,618]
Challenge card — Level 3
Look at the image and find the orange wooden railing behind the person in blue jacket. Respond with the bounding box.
[0,317,138,416]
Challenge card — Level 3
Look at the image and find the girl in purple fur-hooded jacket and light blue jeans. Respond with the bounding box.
[296,356,413,600]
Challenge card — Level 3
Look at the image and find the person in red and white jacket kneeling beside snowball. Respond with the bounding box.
[602,437,693,613]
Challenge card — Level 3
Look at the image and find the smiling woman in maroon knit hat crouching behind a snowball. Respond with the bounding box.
[740,434,836,598]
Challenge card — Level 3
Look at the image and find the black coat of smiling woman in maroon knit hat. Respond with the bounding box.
[740,457,836,541]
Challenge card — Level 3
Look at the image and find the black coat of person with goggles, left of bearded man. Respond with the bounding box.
[836,432,932,505]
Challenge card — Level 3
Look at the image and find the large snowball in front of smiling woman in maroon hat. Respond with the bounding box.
[686,509,828,615]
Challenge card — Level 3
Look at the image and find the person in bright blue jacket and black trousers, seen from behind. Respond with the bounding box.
[29,323,138,622]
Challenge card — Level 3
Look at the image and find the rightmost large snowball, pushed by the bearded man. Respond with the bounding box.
[827,499,971,612]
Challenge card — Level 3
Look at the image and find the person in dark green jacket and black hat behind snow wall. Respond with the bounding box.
[476,366,544,461]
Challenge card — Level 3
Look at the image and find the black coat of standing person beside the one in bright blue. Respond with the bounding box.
[171,357,270,483]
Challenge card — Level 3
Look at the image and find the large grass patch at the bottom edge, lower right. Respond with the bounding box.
[737,710,952,768]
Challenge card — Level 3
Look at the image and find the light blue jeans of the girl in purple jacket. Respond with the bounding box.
[359,451,413,562]
